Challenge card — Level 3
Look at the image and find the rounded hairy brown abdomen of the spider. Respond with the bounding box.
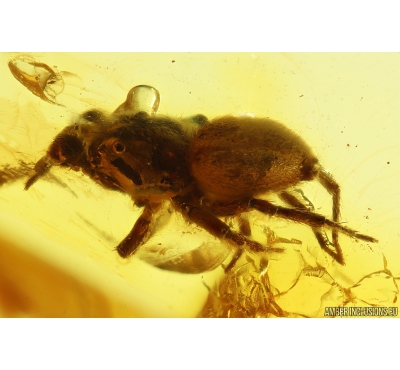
[189,116,318,200]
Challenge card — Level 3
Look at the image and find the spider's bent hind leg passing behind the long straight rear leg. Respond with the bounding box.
[279,190,344,265]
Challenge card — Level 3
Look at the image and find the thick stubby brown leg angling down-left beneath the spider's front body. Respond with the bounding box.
[116,202,161,258]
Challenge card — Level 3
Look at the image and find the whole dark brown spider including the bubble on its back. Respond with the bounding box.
[25,85,377,271]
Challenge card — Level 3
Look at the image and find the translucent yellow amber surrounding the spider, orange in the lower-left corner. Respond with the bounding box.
[0,53,400,317]
